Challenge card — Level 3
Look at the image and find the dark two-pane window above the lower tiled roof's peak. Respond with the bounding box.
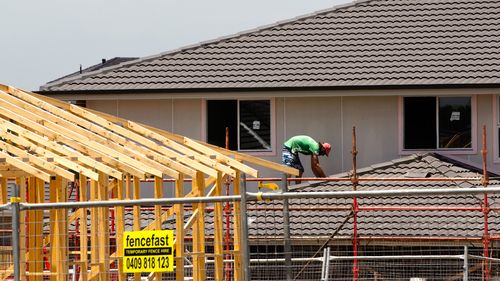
[403,97,472,150]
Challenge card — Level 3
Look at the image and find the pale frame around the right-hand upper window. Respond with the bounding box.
[398,94,477,155]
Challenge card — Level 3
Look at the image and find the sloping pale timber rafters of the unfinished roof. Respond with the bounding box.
[0,85,295,182]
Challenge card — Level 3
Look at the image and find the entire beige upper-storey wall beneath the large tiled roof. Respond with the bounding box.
[87,92,500,180]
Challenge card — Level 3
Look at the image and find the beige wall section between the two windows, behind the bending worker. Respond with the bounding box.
[275,96,398,177]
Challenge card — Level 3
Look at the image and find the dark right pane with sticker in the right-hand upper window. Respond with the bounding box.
[439,97,471,148]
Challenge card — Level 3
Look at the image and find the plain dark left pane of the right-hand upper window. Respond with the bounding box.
[404,97,436,149]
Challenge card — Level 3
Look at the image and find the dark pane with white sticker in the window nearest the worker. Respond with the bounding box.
[239,100,271,150]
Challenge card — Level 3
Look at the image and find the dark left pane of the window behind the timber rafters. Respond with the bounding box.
[207,100,238,150]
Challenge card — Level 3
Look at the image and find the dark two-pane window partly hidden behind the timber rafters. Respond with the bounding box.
[207,100,272,151]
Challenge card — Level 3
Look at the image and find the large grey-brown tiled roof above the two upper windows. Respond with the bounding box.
[41,0,500,91]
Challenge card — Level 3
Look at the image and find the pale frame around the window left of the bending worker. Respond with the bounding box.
[201,97,277,156]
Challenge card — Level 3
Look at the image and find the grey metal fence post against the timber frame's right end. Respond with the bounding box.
[240,173,251,281]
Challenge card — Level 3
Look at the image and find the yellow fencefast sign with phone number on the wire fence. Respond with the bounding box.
[123,230,174,272]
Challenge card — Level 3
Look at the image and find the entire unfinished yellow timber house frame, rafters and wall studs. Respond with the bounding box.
[0,84,298,281]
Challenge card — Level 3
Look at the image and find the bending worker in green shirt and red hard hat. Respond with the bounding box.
[282,135,332,183]
